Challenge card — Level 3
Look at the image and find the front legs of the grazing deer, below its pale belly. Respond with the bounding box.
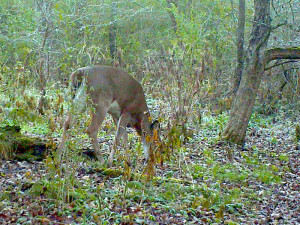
[108,113,130,166]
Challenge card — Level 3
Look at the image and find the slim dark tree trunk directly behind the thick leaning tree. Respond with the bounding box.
[233,0,245,93]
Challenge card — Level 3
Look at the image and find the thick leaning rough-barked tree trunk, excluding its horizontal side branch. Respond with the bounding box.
[223,0,271,144]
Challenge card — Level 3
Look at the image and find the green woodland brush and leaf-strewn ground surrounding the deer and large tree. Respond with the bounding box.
[0,0,300,224]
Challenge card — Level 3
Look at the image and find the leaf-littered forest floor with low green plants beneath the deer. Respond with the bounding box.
[0,101,300,224]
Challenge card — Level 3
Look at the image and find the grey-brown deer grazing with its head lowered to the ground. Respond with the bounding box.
[58,65,159,166]
